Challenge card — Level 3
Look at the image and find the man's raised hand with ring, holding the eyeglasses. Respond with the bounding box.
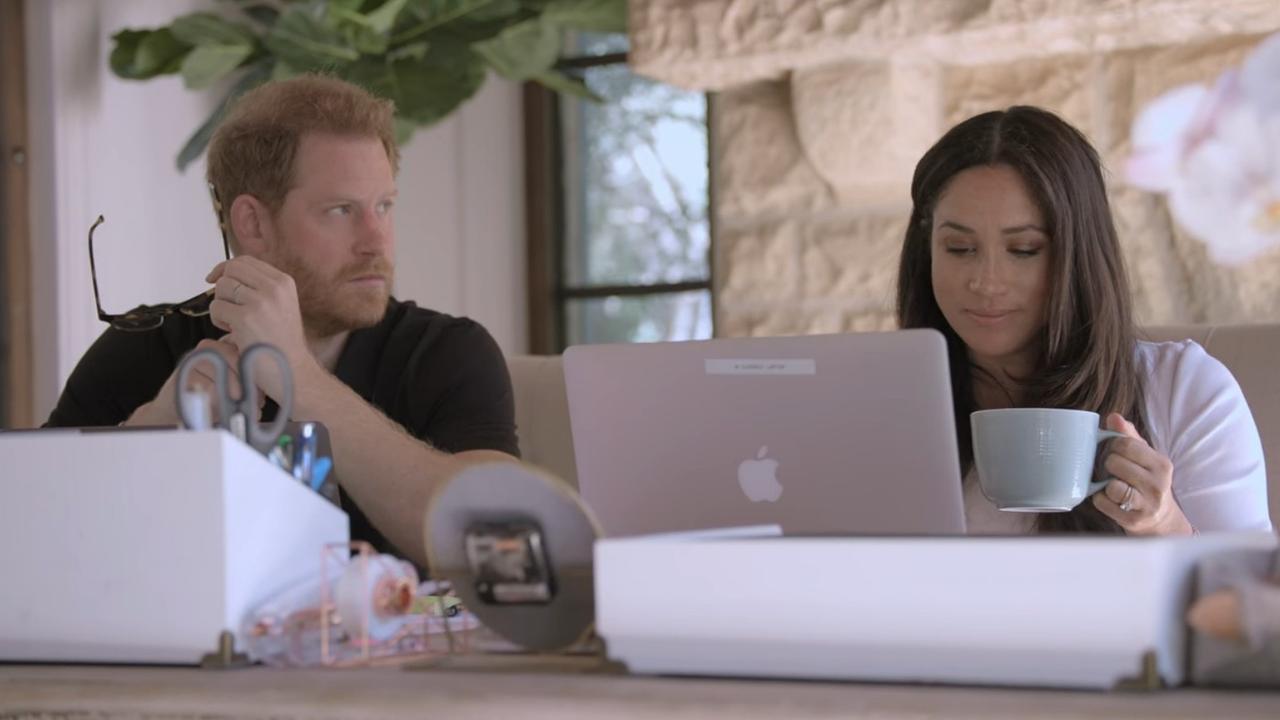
[206,255,316,400]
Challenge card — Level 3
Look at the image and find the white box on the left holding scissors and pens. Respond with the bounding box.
[0,430,348,664]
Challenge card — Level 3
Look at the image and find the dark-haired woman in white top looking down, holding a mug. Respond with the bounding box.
[897,106,1271,536]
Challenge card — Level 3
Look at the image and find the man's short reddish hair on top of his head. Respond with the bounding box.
[206,74,399,243]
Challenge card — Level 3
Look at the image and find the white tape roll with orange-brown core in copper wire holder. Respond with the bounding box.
[333,555,417,643]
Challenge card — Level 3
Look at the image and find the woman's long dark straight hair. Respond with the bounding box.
[897,106,1147,533]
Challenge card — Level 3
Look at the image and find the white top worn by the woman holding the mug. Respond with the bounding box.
[964,340,1271,534]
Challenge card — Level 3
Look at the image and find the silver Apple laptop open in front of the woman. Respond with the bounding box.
[564,329,965,537]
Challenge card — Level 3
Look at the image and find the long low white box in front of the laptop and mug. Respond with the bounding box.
[595,533,1276,688]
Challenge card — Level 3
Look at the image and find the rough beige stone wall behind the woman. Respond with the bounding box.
[631,0,1280,336]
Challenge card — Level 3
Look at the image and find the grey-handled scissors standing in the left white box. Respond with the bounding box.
[178,342,293,455]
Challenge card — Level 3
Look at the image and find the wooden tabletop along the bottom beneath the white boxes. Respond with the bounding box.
[0,665,1280,720]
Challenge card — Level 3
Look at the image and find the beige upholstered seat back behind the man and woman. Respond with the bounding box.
[507,324,1280,528]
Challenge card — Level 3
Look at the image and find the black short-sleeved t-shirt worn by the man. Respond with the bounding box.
[45,299,520,552]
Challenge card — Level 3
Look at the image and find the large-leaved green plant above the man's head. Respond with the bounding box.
[110,0,626,170]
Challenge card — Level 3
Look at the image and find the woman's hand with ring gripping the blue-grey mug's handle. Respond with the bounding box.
[1093,413,1194,536]
